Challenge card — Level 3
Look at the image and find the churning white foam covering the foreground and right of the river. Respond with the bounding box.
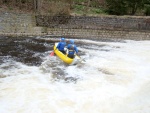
[0,40,150,113]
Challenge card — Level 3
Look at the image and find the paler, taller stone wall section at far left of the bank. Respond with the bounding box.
[0,12,45,36]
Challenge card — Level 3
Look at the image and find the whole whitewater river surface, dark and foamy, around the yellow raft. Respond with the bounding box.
[0,36,150,113]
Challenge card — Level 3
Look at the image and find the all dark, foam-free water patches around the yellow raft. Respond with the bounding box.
[0,36,117,81]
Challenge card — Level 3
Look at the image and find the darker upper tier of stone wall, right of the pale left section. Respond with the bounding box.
[36,16,150,31]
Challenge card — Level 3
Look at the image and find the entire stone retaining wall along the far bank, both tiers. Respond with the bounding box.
[0,13,150,40]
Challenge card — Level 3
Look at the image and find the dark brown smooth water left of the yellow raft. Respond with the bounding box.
[0,37,54,65]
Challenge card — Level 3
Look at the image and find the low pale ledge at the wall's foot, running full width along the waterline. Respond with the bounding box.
[0,27,150,40]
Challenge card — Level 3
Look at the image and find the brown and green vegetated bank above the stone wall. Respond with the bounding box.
[0,0,150,16]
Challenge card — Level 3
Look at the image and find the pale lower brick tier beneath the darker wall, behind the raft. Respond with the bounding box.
[47,28,150,40]
